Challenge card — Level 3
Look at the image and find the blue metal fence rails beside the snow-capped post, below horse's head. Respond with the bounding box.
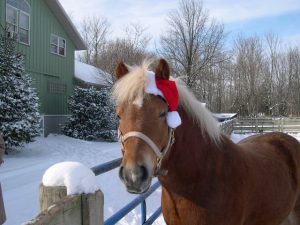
[91,158,161,225]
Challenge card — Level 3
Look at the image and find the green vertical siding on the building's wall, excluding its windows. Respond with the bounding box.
[0,0,75,115]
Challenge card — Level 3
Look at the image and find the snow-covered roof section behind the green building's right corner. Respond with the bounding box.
[75,60,111,86]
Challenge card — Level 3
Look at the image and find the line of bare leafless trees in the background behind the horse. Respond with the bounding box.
[75,7,300,116]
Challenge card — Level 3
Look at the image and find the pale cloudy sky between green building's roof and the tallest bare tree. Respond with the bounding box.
[60,0,177,42]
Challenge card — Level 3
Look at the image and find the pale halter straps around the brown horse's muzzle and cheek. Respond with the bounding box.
[118,128,175,175]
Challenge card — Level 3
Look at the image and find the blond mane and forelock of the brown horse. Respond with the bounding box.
[112,60,221,143]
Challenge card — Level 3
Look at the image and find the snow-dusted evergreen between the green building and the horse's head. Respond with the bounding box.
[62,87,118,141]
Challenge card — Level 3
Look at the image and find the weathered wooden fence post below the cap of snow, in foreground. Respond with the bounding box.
[26,184,104,225]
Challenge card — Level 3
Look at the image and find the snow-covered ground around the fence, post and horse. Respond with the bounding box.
[0,134,300,225]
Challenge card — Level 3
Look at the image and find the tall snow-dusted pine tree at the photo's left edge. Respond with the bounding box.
[0,27,40,149]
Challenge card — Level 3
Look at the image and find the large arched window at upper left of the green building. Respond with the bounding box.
[6,0,30,44]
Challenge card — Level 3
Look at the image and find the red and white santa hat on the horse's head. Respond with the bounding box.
[145,71,181,128]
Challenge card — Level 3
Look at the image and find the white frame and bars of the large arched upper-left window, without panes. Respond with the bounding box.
[5,0,31,46]
